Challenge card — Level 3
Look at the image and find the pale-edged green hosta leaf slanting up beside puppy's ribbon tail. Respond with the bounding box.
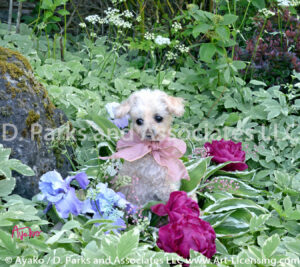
[180,158,210,192]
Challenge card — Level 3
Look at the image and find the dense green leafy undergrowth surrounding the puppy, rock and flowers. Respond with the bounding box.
[0,1,300,266]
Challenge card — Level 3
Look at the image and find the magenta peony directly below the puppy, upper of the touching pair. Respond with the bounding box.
[151,191,200,222]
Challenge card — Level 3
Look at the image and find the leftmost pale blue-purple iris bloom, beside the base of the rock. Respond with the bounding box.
[38,171,89,218]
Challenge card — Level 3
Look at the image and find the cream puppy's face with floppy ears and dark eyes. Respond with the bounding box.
[116,89,184,141]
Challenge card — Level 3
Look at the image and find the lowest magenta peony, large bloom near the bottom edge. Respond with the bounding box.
[157,215,216,259]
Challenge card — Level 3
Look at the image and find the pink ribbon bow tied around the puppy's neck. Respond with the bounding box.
[100,131,190,181]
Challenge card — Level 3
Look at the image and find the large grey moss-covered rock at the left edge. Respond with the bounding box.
[0,47,71,198]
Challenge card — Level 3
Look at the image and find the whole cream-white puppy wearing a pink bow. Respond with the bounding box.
[112,89,189,206]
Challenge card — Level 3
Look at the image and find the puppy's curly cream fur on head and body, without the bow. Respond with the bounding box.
[116,89,184,205]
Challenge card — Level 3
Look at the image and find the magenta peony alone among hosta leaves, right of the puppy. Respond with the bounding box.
[204,139,248,171]
